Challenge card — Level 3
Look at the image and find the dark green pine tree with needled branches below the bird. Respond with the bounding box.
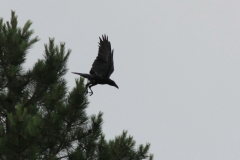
[0,11,153,160]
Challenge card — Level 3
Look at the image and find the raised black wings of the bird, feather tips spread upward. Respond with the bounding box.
[90,35,114,78]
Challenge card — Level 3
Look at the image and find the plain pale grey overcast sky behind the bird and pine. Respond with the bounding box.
[0,0,240,160]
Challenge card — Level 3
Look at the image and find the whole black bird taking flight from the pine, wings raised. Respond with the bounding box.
[72,35,118,96]
